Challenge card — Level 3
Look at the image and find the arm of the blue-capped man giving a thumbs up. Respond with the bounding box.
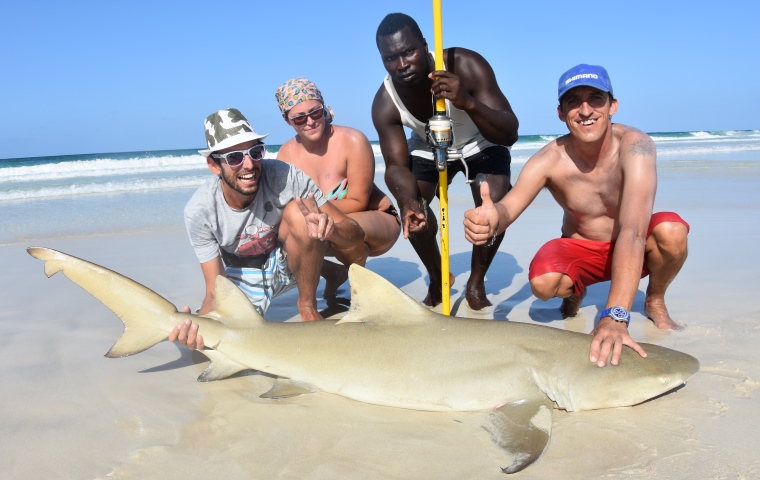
[464,145,557,245]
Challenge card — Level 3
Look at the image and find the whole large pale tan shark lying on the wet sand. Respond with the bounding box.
[27,247,699,473]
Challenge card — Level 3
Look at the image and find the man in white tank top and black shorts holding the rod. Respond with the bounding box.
[372,13,518,310]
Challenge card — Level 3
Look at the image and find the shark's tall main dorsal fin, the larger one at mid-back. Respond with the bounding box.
[338,264,439,325]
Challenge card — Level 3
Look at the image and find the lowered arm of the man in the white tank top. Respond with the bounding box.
[372,86,425,238]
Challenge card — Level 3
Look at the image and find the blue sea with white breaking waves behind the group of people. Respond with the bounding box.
[0,130,760,245]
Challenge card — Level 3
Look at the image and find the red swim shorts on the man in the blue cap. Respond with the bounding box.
[528,212,689,295]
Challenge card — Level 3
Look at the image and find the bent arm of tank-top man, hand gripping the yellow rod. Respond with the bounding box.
[430,48,519,146]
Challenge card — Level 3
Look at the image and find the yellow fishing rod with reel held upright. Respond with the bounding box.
[428,0,454,315]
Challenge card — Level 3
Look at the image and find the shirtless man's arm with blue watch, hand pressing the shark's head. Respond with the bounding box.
[589,130,657,367]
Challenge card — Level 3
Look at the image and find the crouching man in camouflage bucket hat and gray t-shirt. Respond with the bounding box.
[169,108,366,348]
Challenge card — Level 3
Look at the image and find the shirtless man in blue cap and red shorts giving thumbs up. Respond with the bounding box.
[464,64,689,367]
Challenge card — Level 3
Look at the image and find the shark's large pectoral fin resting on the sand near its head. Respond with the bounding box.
[483,396,554,473]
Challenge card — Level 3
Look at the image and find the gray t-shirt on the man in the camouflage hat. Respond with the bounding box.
[185,160,327,268]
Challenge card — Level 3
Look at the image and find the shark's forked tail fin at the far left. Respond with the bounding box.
[26,247,183,358]
